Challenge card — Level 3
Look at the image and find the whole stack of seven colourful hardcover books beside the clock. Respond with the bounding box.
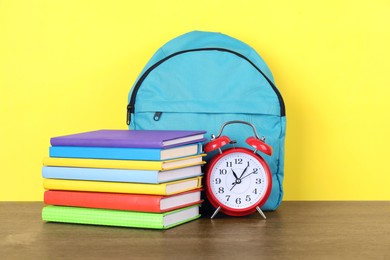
[42,130,205,229]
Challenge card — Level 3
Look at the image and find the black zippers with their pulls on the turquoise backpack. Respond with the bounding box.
[126,48,286,125]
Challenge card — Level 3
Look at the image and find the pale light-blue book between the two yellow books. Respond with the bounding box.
[42,165,203,183]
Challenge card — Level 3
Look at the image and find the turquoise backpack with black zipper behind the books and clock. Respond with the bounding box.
[127,31,286,210]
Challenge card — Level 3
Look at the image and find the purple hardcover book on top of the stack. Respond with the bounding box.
[50,130,206,149]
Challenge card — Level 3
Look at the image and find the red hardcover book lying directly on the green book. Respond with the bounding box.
[44,189,202,212]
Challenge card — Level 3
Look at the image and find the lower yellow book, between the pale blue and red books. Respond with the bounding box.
[43,177,202,195]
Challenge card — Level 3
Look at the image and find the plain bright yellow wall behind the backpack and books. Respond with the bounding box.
[0,0,390,201]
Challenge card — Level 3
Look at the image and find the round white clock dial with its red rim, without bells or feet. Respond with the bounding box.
[208,149,271,210]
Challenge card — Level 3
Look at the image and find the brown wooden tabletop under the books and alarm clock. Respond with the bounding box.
[0,201,390,260]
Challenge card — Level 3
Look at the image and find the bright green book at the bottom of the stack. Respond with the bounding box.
[42,205,200,229]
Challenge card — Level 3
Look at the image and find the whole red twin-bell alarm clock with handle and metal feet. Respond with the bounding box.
[204,120,272,219]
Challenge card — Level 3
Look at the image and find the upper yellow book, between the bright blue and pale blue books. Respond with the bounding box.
[43,154,205,171]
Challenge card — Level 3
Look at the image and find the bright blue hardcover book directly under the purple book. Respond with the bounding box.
[49,143,202,161]
